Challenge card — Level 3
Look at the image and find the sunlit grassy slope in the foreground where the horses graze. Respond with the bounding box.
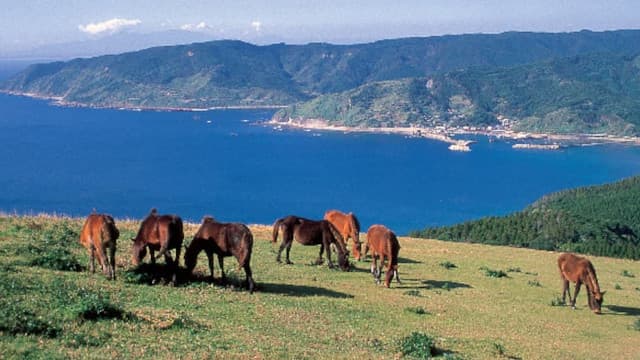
[0,216,640,359]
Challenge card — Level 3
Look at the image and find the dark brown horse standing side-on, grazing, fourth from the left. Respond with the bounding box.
[272,215,349,271]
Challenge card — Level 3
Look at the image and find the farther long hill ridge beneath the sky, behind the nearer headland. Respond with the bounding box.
[0,30,640,108]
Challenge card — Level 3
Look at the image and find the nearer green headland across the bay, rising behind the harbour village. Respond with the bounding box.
[276,53,640,135]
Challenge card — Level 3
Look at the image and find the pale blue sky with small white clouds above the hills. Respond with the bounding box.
[0,0,640,53]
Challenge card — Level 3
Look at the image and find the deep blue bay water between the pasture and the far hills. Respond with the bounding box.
[0,95,640,234]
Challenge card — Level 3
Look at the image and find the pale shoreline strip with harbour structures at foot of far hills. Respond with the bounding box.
[5,90,640,152]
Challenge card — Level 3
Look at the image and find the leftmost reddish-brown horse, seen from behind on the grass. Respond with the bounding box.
[80,210,120,280]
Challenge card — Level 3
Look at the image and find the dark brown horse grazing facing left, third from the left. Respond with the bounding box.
[184,216,255,293]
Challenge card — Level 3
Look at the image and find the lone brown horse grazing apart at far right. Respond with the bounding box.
[558,253,604,314]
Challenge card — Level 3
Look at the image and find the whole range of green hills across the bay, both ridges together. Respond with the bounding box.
[0,30,640,134]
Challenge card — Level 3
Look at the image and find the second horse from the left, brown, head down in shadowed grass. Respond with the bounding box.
[131,209,184,285]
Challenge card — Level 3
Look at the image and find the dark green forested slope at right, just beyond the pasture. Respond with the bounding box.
[412,177,640,259]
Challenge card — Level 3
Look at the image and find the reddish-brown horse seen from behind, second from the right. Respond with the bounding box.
[364,225,400,287]
